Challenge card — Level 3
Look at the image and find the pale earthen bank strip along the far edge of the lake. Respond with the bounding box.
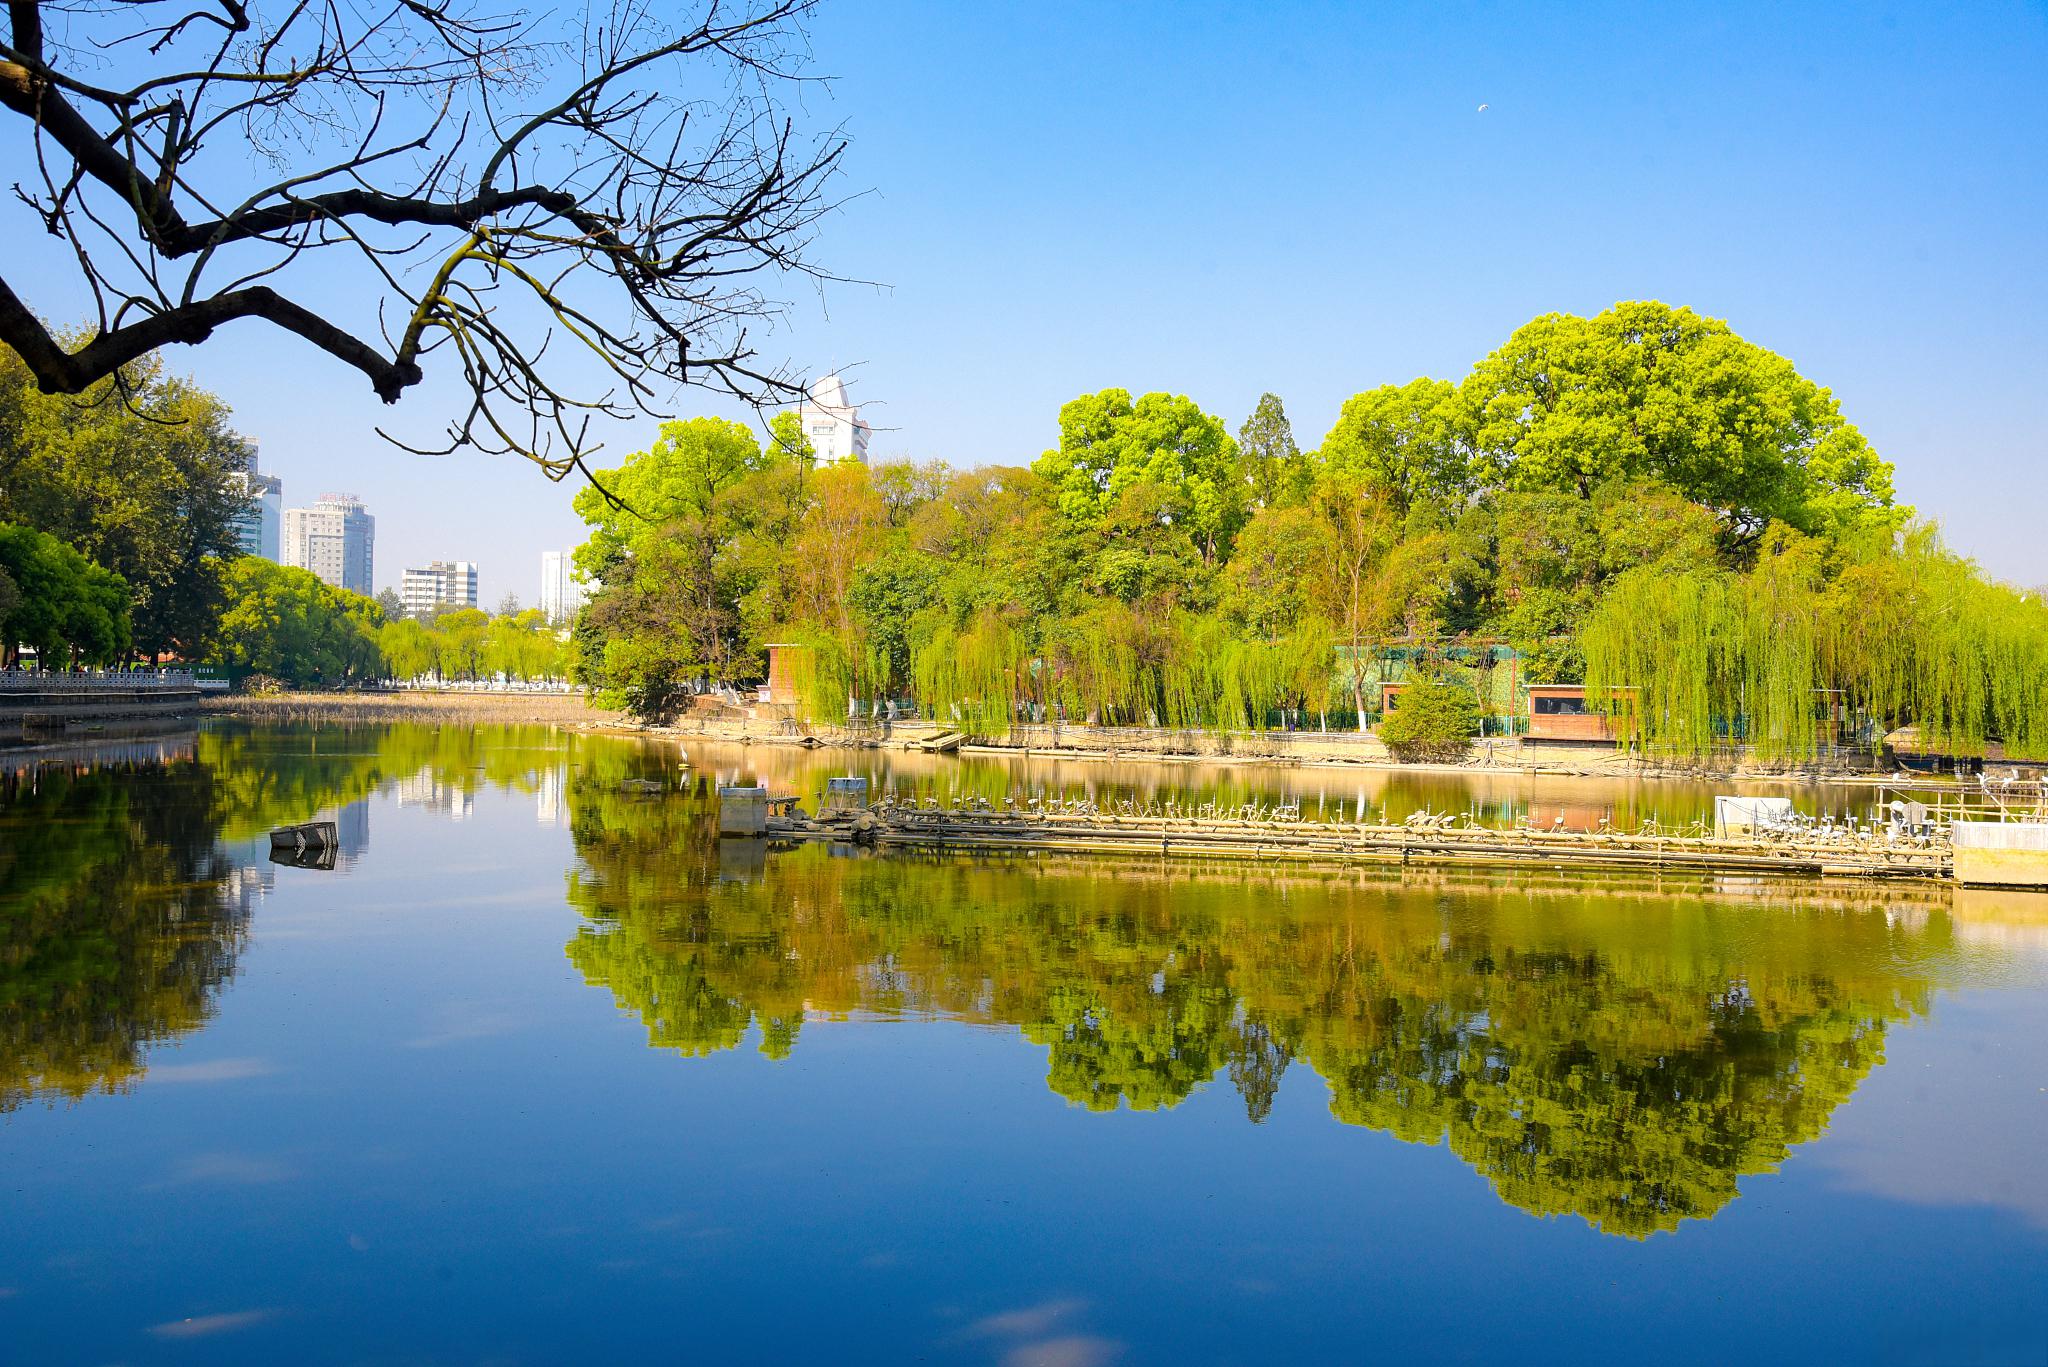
[199,691,1958,789]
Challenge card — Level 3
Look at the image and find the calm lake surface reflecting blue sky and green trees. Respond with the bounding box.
[0,726,2048,1365]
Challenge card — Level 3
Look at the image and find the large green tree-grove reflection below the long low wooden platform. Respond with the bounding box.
[567,779,1960,1238]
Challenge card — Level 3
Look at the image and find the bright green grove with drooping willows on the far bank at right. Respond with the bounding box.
[575,303,2048,760]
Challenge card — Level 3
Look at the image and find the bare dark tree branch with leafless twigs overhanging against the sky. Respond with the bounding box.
[0,0,844,478]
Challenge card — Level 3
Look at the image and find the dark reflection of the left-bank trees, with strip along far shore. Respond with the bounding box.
[0,723,657,1111]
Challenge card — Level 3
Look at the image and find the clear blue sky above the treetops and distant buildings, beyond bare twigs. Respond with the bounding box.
[0,0,2048,600]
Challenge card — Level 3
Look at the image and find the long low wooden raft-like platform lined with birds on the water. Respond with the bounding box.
[766,805,1954,879]
